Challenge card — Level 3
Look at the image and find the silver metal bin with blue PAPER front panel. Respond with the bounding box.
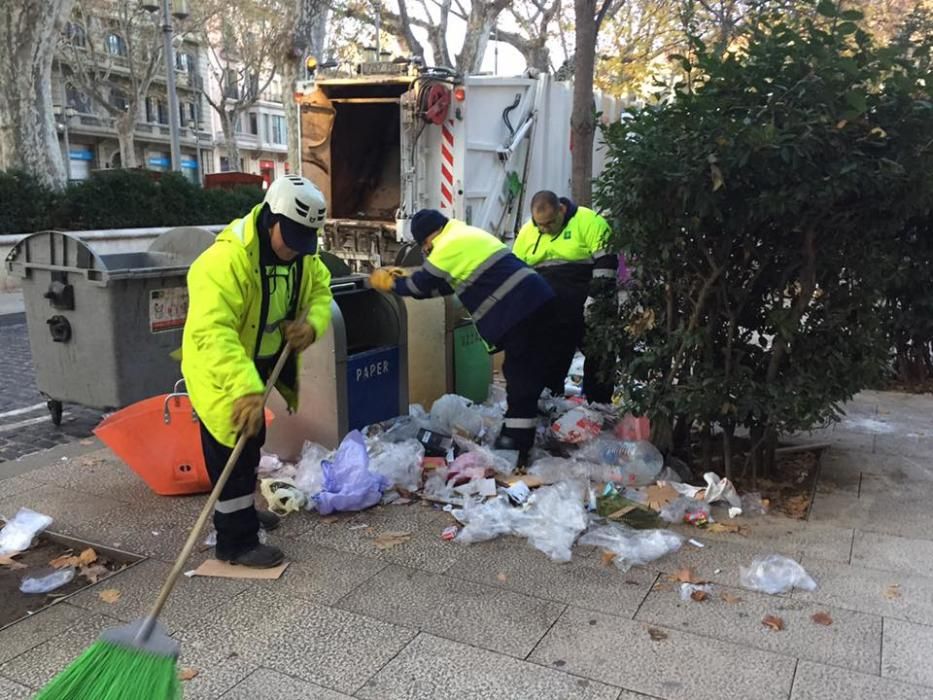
[265,276,408,459]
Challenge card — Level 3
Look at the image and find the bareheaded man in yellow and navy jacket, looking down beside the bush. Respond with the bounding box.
[512,190,619,403]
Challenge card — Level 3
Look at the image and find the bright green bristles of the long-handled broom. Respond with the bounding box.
[35,640,181,700]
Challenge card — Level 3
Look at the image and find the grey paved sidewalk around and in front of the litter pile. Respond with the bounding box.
[0,392,933,700]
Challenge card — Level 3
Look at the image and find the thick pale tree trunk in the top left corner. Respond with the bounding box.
[0,0,74,187]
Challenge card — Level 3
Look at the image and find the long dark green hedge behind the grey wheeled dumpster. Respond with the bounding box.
[0,170,263,234]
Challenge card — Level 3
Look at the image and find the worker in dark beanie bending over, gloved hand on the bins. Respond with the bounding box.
[370,209,554,465]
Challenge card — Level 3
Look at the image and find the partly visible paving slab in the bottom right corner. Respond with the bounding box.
[790,661,929,700]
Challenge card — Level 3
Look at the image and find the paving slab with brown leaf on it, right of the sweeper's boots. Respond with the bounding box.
[297,504,463,573]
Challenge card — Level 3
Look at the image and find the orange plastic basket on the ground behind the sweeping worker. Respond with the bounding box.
[94,394,274,496]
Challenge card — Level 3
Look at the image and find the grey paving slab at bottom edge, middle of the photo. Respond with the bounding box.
[356,633,619,700]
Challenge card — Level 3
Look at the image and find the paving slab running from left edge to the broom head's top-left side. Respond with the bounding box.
[0,615,121,690]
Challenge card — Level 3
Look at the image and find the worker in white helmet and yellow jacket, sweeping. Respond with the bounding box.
[182,175,333,568]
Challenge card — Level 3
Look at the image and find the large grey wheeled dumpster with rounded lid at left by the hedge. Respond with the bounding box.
[6,227,214,424]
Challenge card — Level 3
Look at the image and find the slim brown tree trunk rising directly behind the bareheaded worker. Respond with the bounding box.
[570,0,596,206]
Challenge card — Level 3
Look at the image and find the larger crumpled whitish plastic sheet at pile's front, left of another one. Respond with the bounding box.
[454,482,586,561]
